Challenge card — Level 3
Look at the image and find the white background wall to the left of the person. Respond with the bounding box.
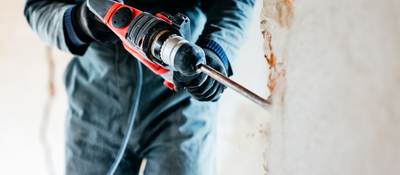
[0,1,68,174]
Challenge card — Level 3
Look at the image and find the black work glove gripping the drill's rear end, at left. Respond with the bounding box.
[71,1,117,43]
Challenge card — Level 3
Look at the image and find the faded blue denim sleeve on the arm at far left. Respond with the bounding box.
[24,0,83,54]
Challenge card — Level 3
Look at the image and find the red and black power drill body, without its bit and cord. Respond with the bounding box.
[87,0,205,89]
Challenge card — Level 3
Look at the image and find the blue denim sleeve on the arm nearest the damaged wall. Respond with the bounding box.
[198,0,255,73]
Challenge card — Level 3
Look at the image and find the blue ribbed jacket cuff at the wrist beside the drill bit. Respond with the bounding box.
[197,39,233,76]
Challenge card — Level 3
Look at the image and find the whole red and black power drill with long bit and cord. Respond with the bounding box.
[87,0,269,175]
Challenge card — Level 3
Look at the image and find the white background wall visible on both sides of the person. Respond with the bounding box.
[0,1,269,175]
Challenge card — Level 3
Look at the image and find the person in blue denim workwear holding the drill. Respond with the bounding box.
[24,0,254,175]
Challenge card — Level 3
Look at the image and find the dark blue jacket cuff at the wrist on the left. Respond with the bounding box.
[63,6,88,55]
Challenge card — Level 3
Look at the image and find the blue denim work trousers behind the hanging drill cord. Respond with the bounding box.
[65,41,217,175]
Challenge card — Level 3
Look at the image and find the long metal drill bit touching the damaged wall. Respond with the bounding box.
[198,64,271,110]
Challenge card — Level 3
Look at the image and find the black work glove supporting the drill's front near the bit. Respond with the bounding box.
[174,49,227,101]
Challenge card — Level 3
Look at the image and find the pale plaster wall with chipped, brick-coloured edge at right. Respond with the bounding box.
[261,0,400,175]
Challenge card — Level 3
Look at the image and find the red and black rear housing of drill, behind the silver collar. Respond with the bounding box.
[87,0,177,88]
